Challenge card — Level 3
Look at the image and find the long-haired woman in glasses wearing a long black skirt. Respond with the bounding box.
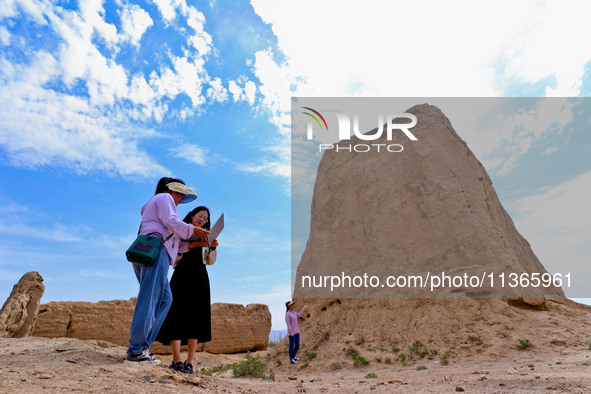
[156,206,218,373]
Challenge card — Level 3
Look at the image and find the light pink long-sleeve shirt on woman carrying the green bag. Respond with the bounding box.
[140,193,193,264]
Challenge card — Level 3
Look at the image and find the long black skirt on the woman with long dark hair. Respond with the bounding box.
[156,247,211,345]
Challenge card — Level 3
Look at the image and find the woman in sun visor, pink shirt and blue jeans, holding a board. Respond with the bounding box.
[126,177,209,364]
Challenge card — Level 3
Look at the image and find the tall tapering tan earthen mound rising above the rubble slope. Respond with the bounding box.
[295,104,564,299]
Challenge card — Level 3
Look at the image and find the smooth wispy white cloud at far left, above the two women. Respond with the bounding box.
[0,54,164,176]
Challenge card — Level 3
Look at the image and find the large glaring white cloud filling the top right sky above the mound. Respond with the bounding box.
[251,0,591,165]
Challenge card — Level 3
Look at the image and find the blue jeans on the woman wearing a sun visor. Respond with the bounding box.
[129,246,172,354]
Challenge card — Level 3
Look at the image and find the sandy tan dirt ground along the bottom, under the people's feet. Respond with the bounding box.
[0,337,591,393]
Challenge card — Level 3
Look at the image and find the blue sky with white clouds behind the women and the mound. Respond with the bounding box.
[0,0,591,329]
